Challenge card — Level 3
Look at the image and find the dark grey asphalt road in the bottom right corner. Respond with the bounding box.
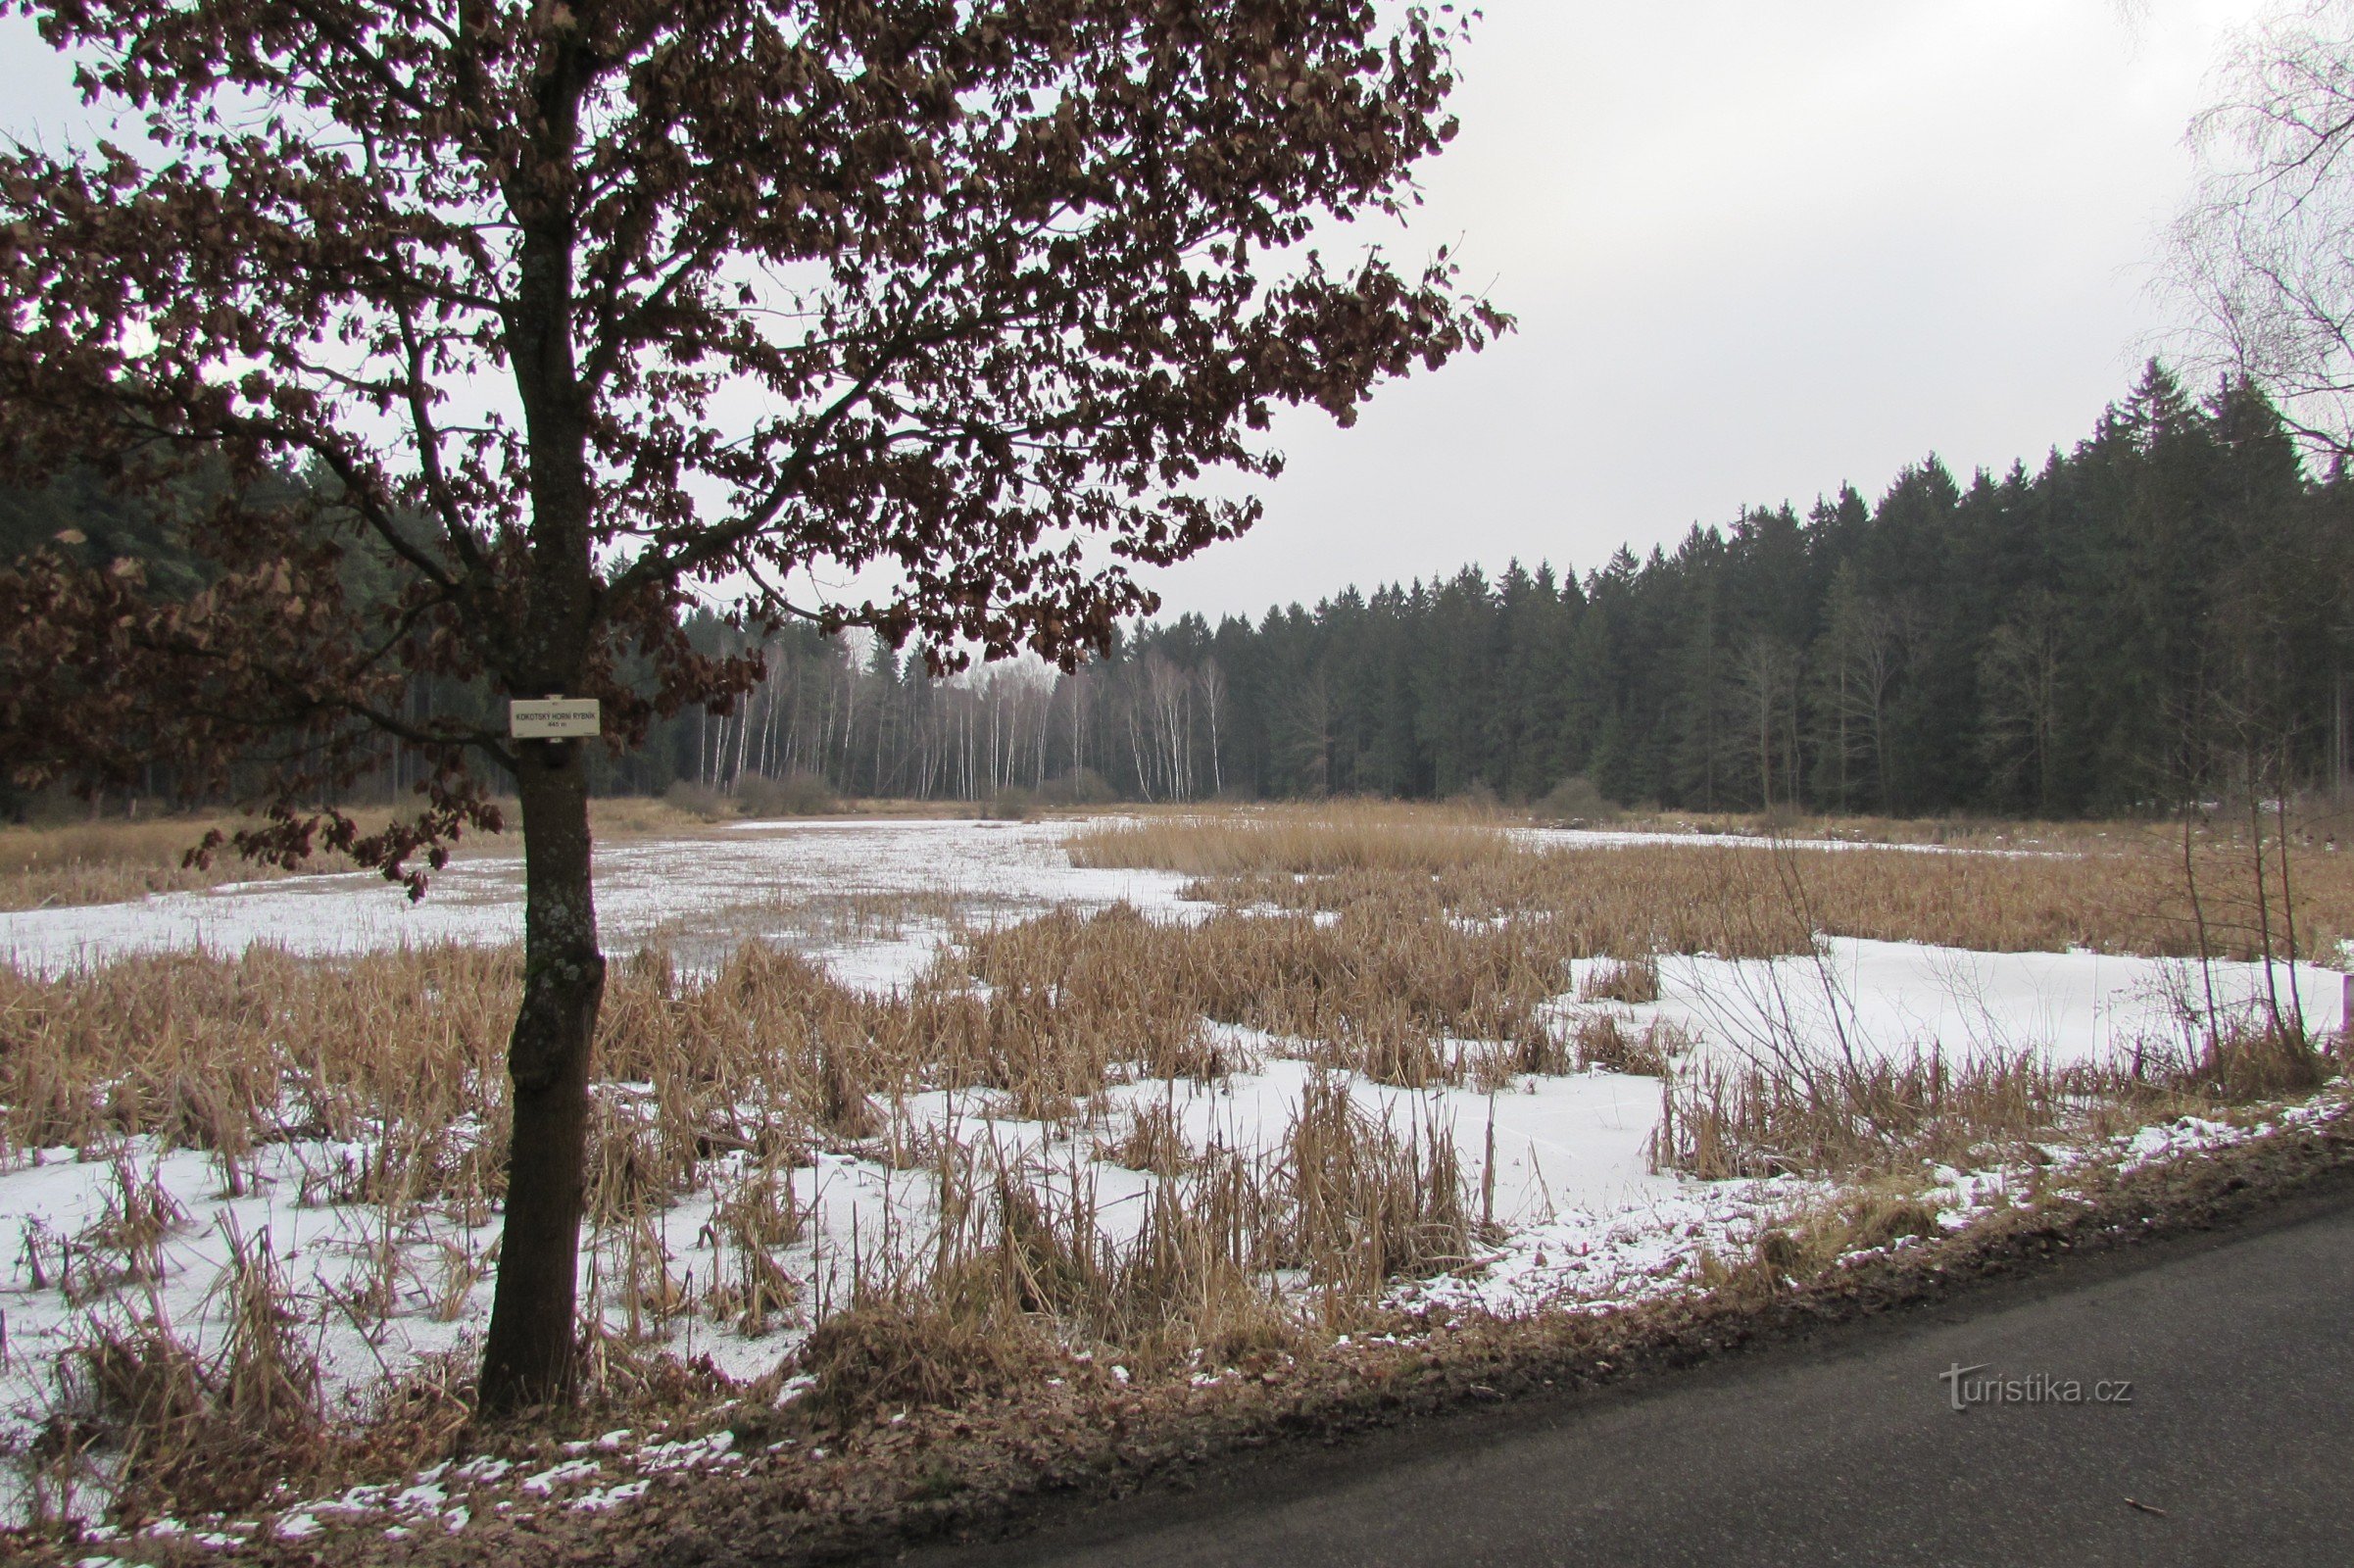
[904,1182,2354,1568]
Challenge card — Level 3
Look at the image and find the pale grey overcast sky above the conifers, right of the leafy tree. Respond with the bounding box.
[0,0,2262,630]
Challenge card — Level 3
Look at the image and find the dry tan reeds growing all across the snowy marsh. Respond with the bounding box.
[0,806,2354,1507]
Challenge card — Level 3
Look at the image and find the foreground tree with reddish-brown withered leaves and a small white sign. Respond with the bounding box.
[0,0,1504,1405]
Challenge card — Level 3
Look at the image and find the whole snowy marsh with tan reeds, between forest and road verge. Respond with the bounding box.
[0,808,2354,1528]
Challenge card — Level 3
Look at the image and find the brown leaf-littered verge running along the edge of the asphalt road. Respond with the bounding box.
[459,1090,2354,1568]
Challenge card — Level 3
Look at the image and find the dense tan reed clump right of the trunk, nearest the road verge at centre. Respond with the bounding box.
[801,1078,1471,1422]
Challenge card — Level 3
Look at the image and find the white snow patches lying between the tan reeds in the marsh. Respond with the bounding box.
[0,821,2344,1511]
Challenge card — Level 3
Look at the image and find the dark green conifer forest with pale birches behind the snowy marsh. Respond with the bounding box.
[0,365,2354,817]
